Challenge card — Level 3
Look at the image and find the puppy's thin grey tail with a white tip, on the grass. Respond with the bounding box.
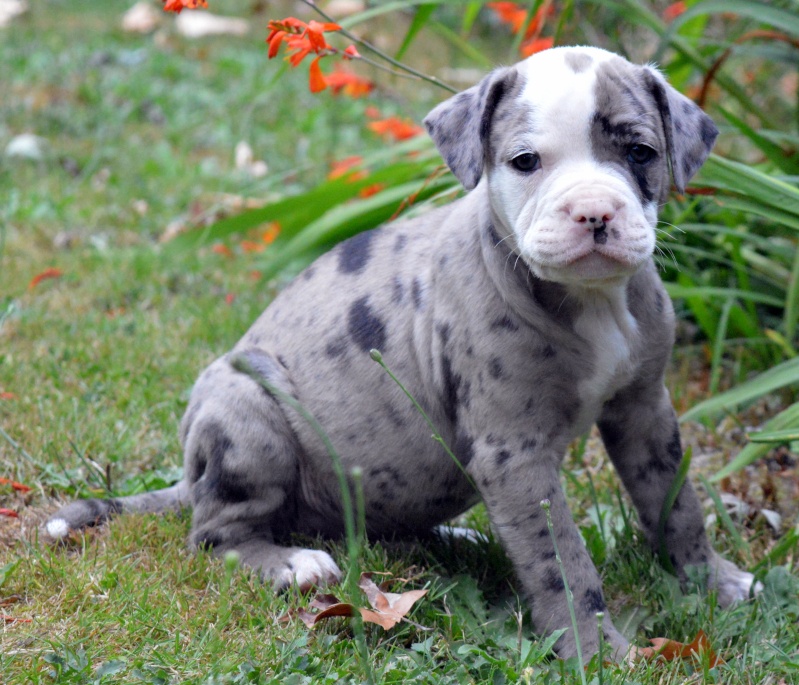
[44,480,190,540]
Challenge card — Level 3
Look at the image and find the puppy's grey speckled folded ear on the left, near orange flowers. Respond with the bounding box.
[424,68,518,190]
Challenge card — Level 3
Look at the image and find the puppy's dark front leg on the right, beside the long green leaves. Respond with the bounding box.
[598,381,754,606]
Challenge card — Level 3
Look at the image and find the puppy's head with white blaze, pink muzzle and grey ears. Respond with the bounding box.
[425,47,718,286]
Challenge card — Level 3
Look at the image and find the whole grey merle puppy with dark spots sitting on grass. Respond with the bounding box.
[47,47,753,658]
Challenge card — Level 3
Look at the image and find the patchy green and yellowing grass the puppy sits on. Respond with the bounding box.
[0,1,799,685]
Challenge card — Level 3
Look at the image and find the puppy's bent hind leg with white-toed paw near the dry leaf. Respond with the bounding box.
[181,350,341,590]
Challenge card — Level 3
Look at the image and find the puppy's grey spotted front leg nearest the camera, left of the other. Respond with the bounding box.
[468,435,629,660]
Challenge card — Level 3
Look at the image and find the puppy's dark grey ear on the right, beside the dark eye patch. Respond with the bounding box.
[645,67,719,193]
